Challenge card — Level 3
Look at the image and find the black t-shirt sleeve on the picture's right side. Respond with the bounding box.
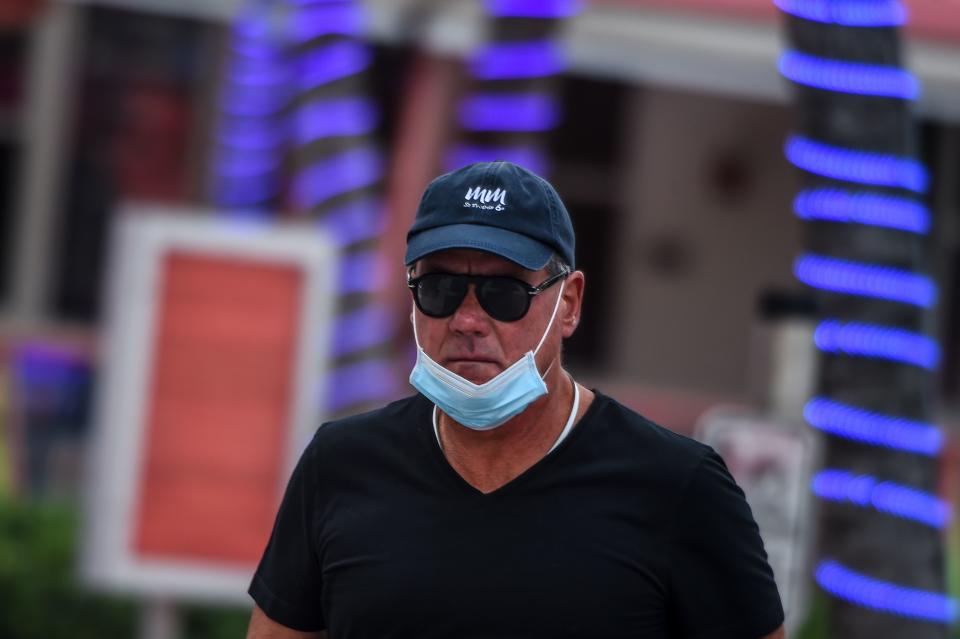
[668,450,783,639]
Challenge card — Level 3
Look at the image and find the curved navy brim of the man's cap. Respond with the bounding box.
[403,224,554,271]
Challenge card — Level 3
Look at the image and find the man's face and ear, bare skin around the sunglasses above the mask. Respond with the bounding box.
[414,249,583,384]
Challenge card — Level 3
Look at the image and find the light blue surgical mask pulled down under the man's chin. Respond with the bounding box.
[410,282,564,430]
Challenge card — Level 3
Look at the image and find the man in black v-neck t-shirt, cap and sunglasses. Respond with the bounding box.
[248,162,783,639]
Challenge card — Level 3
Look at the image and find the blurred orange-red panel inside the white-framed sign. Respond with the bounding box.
[133,253,303,565]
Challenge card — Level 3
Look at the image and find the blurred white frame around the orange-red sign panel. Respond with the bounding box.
[80,209,338,603]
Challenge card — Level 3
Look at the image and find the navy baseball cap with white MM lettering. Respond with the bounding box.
[404,162,574,271]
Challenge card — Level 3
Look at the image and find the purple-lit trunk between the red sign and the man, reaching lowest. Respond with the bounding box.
[286,0,401,415]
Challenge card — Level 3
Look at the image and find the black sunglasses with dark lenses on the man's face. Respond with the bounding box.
[407,270,570,322]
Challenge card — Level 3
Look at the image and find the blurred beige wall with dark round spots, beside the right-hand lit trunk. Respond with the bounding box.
[610,89,801,396]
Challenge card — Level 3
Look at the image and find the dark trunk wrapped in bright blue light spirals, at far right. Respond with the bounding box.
[775,0,957,639]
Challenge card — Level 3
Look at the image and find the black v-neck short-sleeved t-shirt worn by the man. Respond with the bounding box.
[250,393,783,639]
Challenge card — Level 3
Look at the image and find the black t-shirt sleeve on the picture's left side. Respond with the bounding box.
[248,438,326,632]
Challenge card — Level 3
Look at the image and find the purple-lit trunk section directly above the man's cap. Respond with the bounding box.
[446,0,580,174]
